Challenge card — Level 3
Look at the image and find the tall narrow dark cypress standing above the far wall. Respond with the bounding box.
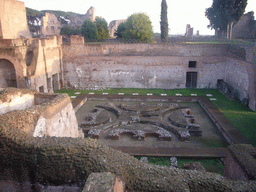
[160,0,168,42]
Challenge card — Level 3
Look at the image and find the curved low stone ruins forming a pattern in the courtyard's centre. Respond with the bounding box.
[80,102,202,141]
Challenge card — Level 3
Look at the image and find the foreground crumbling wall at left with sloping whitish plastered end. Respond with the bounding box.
[0,88,83,138]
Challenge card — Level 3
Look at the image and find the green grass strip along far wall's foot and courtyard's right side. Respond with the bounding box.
[57,88,256,147]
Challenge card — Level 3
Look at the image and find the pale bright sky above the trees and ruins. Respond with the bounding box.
[20,0,256,35]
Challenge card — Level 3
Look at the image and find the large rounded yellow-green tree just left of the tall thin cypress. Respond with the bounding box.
[122,13,153,43]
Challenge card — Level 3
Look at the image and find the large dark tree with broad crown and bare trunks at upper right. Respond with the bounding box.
[205,0,247,39]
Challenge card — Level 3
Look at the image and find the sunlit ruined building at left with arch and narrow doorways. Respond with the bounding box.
[0,36,63,92]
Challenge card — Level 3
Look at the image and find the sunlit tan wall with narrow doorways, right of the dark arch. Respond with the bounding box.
[27,36,63,93]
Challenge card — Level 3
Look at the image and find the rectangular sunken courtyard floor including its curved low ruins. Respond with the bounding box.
[72,95,248,157]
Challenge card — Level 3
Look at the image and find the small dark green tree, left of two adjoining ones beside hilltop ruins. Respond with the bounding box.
[81,20,98,41]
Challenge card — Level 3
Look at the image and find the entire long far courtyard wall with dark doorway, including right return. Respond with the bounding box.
[63,41,255,110]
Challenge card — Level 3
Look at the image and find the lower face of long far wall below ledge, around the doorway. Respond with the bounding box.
[64,56,225,89]
